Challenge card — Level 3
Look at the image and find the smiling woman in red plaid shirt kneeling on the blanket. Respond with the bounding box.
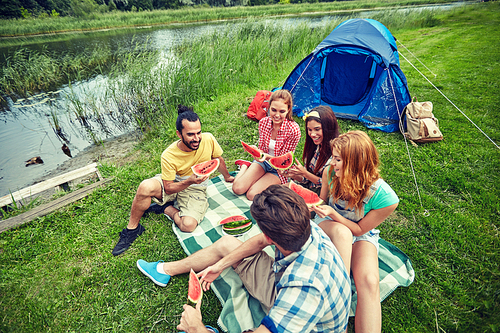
[233,89,300,200]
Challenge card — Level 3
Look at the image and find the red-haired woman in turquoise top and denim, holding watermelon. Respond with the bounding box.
[313,131,399,332]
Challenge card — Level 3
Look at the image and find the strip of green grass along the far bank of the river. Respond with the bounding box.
[0,0,454,39]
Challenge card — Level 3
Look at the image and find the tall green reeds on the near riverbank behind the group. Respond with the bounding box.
[99,4,448,129]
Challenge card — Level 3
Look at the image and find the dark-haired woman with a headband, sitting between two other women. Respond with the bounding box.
[283,105,339,194]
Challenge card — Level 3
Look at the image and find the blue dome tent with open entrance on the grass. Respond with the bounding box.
[282,19,411,132]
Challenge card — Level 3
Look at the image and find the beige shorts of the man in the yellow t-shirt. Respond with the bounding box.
[153,174,208,223]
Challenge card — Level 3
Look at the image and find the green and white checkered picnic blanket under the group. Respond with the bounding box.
[172,173,415,333]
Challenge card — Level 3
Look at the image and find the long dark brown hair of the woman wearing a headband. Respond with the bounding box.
[302,105,340,174]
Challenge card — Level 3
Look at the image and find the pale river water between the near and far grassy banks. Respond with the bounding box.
[0,3,472,196]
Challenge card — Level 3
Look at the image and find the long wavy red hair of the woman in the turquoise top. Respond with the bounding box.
[328,131,380,216]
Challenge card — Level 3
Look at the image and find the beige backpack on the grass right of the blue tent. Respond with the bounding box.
[403,97,443,143]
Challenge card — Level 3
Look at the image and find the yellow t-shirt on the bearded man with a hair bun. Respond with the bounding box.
[161,133,222,181]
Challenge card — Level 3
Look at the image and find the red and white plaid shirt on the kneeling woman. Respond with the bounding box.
[259,117,300,184]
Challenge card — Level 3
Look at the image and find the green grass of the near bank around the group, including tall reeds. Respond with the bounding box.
[0,2,500,332]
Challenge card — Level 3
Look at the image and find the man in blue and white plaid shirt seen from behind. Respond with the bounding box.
[137,185,351,333]
